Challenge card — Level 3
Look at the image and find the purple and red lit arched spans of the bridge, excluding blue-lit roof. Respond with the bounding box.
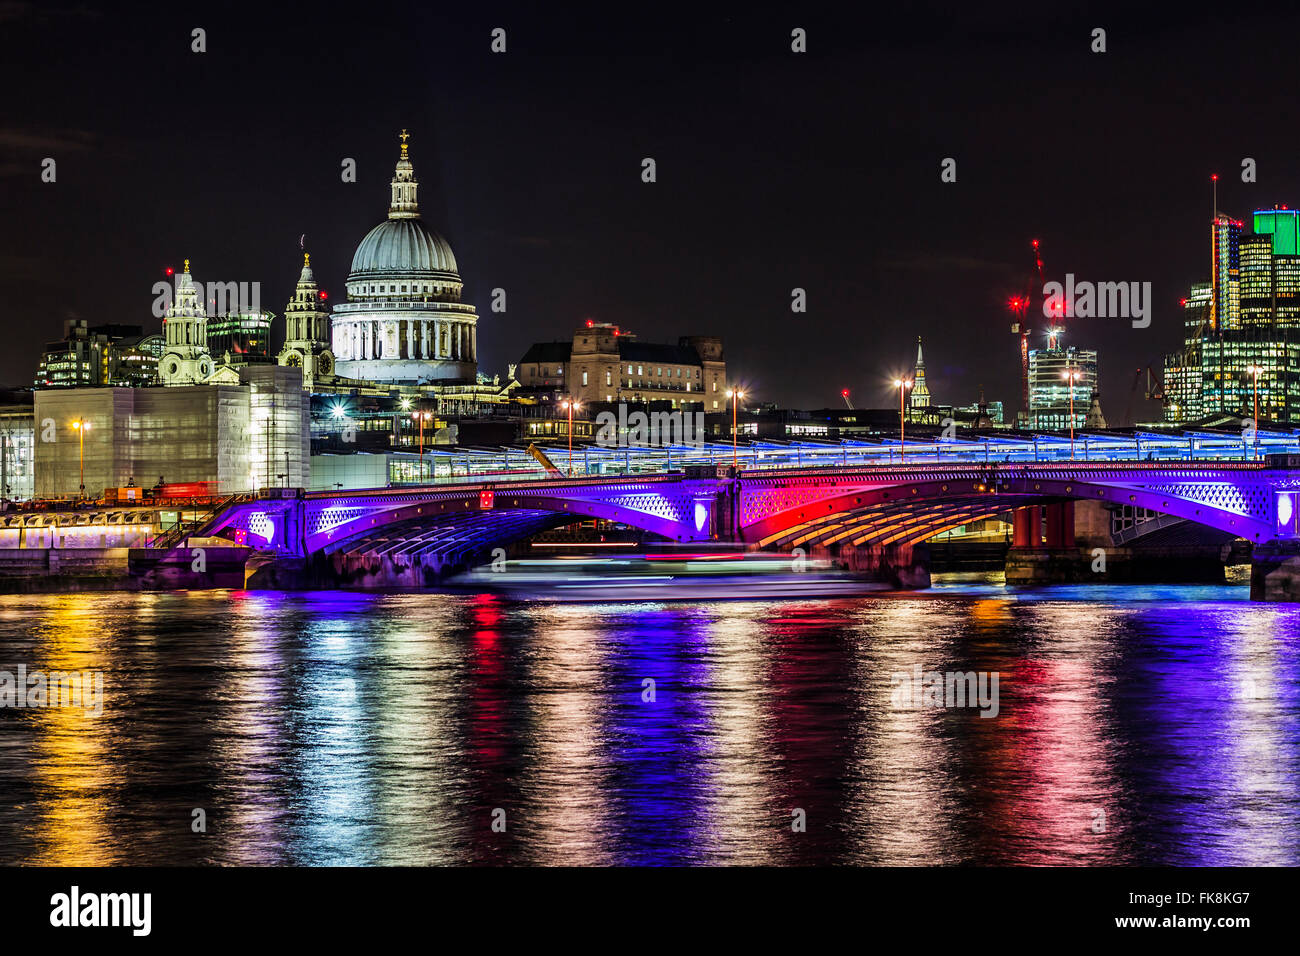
[203,462,1300,570]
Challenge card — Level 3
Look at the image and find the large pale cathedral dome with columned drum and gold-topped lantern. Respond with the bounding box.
[332,130,478,385]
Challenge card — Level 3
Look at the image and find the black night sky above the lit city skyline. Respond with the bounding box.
[0,3,1300,424]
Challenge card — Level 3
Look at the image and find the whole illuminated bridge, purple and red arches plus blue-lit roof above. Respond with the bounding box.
[180,434,1300,600]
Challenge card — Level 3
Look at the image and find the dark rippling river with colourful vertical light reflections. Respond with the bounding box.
[0,581,1300,865]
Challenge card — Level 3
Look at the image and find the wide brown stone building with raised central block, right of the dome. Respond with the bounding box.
[516,321,728,412]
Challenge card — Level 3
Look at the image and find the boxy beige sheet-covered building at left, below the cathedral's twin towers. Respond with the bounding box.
[34,365,311,498]
